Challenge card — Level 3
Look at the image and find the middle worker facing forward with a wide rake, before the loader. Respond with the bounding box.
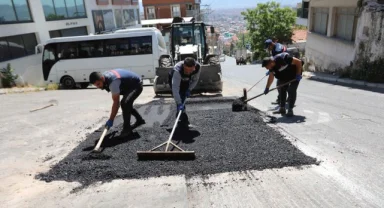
[168,57,200,127]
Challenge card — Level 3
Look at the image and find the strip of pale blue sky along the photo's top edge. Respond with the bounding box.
[139,0,302,10]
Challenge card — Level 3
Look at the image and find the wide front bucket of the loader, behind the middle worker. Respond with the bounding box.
[153,64,223,95]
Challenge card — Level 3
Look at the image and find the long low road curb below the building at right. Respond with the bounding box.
[303,72,384,89]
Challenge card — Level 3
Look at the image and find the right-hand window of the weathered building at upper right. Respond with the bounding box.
[335,8,358,41]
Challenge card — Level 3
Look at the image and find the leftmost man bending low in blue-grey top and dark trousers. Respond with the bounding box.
[89,69,145,137]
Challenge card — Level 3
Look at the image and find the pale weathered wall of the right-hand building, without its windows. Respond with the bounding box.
[305,0,384,73]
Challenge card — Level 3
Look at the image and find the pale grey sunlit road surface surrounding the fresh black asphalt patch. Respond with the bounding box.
[0,58,384,208]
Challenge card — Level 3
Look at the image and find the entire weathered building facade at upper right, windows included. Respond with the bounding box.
[305,0,384,72]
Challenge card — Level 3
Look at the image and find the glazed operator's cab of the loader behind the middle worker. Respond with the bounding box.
[171,22,207,61]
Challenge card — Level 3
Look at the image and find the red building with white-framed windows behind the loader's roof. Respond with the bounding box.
[143,0,201,20]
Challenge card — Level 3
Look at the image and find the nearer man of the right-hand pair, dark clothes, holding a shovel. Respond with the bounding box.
[262,52,303,117]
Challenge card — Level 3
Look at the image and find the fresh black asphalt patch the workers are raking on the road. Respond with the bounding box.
[36,98,316,186]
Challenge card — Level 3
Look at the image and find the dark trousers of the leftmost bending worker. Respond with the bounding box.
[120,85,143,130]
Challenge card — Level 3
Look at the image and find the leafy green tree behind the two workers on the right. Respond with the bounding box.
[241,1,296,58]
